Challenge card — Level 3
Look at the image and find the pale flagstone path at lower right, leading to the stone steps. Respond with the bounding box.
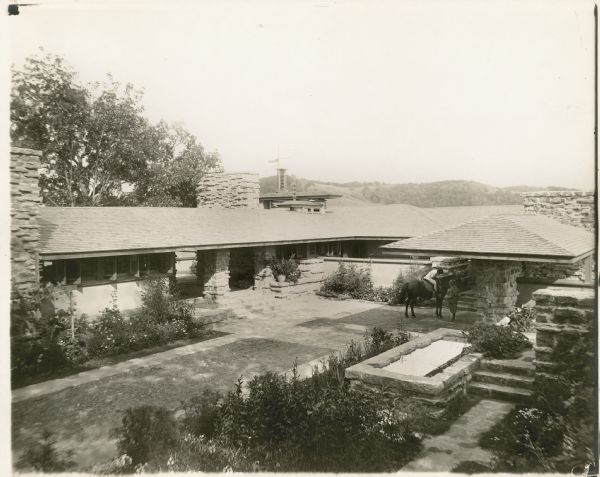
[401,399,514,472]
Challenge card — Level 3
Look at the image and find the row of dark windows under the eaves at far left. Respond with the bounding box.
[41,253,175,285]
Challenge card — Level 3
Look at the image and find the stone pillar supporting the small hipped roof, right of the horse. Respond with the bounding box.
[470,259,521,323]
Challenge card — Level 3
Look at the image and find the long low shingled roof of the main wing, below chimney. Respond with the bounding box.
[40,204,524,258]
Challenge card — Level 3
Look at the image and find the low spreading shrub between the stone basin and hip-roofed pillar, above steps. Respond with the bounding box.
[462,323,533,359]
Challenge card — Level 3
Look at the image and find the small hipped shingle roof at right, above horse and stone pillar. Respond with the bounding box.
[382,215,594,262]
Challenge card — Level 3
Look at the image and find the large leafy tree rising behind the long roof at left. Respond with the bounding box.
[11,50,221,207]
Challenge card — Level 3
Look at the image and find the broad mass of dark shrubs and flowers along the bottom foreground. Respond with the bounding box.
[110,329,420,472]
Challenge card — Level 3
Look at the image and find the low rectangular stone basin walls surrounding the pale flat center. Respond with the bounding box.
[345,328,481,414]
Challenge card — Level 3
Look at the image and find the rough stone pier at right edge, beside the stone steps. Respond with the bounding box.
[533,287,595,386]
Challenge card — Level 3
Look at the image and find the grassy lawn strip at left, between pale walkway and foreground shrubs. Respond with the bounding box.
[12,338,331,468]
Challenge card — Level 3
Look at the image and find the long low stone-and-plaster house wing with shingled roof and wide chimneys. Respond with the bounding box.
[11,148,593,316]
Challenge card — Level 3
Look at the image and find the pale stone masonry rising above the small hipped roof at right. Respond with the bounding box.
[522,191,596,231]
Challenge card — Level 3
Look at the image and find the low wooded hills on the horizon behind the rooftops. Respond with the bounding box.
[260,176,570,207]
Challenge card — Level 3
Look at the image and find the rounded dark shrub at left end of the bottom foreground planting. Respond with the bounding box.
[114,406,179,466]
